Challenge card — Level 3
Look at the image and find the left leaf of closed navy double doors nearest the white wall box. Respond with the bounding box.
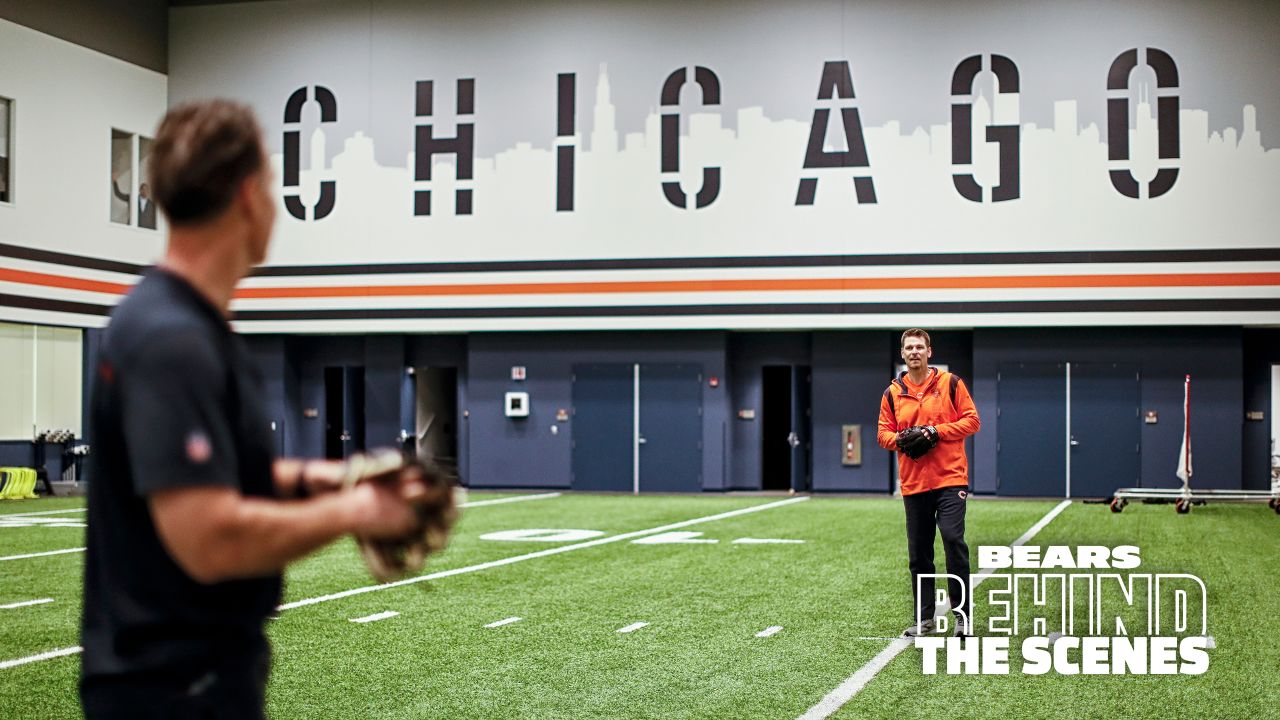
[570,364,635,492]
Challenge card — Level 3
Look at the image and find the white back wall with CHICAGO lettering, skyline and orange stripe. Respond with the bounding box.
[169,0,1280,333]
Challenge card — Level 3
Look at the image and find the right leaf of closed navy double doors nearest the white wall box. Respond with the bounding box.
[640,363,703,492]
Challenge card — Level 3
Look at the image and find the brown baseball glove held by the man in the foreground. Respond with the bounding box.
[343,448,458,583]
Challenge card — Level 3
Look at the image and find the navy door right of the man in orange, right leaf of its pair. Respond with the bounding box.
[1071,363,1142,497]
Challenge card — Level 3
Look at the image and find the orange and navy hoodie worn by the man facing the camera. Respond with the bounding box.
[877,368,982,495]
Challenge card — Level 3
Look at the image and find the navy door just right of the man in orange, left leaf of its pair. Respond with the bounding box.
[996,363,1066,497]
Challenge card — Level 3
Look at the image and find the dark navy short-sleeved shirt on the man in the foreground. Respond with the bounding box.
[82,269,280,684]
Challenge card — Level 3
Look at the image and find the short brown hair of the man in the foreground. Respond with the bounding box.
[147,100,264,225]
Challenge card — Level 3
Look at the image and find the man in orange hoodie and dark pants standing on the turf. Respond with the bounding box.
[877,328,980,637]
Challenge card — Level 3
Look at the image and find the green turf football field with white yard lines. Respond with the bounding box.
[0,493,1280,720]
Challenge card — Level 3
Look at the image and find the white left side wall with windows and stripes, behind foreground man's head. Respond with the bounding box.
[0,20,169,325]
